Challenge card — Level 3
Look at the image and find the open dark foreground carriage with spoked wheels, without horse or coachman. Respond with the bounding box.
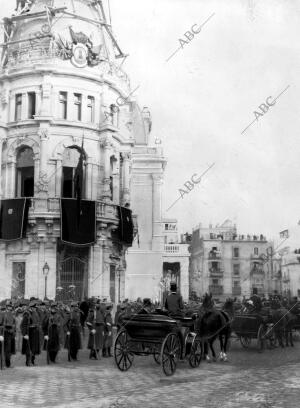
[114,313,202,376]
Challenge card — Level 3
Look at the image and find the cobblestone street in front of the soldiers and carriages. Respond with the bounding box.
[0,341,300,408]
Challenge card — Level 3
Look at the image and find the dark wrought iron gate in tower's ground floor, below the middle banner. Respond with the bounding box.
[57,257,87,301]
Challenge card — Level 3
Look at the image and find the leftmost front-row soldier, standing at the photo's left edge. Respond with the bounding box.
[0,301,16,367]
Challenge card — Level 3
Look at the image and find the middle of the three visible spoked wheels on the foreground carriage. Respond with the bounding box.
[160,333,181,375]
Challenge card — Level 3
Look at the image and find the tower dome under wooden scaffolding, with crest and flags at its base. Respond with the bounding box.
[3,0,124,72]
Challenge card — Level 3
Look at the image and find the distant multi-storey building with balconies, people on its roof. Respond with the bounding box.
[190,220,279,300]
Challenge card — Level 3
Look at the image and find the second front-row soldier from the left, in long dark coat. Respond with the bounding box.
[21,300,41,366]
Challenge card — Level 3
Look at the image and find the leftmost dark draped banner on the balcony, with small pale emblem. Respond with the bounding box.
[0,198,30,241]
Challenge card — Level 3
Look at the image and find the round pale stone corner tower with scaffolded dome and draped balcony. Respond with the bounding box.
[0,0,135,302]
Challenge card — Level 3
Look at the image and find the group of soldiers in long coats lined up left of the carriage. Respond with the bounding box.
[0,298,113,367]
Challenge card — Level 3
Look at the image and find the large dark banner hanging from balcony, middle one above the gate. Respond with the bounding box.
[60,198,96,245]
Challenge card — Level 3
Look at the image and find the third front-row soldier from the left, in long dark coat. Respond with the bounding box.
[43,302,62,363]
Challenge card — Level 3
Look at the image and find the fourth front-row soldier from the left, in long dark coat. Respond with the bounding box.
[66,302,81,360]
